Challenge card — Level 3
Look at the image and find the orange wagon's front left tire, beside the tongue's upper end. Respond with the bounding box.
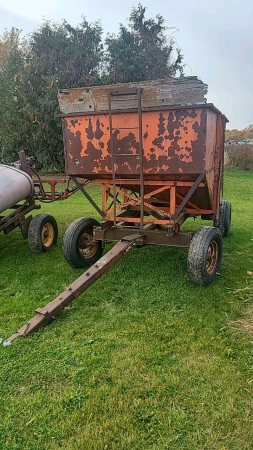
[62,217,104,268]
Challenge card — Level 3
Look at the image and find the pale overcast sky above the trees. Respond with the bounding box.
[0,0,253,129]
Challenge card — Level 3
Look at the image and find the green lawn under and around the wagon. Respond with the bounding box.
[0,172,253,450]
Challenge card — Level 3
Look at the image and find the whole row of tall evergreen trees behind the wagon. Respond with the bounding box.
[0,4,184,171]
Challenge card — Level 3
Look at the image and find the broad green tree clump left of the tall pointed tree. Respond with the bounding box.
[0,19,102,171]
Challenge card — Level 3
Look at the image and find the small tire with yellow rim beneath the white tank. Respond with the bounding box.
[28,214,58,253]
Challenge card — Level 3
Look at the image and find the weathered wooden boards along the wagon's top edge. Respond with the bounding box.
[58,76,207,114]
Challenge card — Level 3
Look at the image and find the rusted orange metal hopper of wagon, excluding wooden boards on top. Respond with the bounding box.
[64,105,224,218]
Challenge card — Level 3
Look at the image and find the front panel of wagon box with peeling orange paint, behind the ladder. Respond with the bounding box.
[63,107,207,180]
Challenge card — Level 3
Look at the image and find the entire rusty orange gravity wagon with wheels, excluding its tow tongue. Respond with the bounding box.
[59,77,231,285]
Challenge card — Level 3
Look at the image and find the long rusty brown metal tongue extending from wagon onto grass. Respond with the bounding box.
[3,239,136,347]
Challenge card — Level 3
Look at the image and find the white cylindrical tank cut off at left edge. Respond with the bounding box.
[0,164,34,213]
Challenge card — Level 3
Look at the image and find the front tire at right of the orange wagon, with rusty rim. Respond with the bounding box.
[187,226,223,286]
